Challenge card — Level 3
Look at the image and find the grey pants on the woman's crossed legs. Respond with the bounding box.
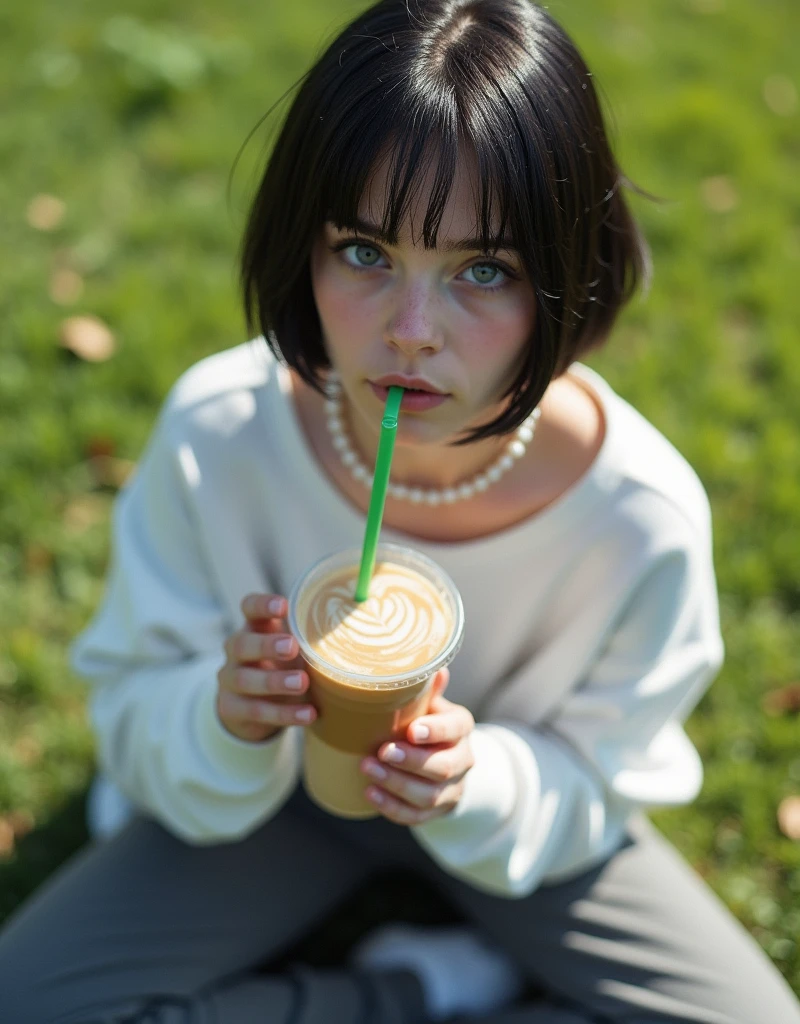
[0,788,800,1024]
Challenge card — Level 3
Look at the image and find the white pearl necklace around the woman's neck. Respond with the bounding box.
[325,373,542,505]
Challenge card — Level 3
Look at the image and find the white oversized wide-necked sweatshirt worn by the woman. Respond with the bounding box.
[72,339,723,897]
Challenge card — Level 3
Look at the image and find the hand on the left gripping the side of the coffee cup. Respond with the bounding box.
[216,594,317,742]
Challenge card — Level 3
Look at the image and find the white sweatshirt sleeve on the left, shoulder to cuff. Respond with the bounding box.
[71,407,300,844]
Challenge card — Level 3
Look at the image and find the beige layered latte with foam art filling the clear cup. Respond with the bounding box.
[297,562,453,817]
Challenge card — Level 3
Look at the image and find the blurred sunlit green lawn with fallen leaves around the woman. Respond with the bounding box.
[0,0,800,994]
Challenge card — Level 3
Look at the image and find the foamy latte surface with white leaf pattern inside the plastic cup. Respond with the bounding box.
[298,562,453,681]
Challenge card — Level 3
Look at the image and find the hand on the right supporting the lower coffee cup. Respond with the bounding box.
[362,669,475,825]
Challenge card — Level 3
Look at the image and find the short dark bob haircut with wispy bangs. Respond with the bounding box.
[241,0,654,445]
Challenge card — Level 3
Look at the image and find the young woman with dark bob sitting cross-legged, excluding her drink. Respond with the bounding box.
[0,0,800,1024]
